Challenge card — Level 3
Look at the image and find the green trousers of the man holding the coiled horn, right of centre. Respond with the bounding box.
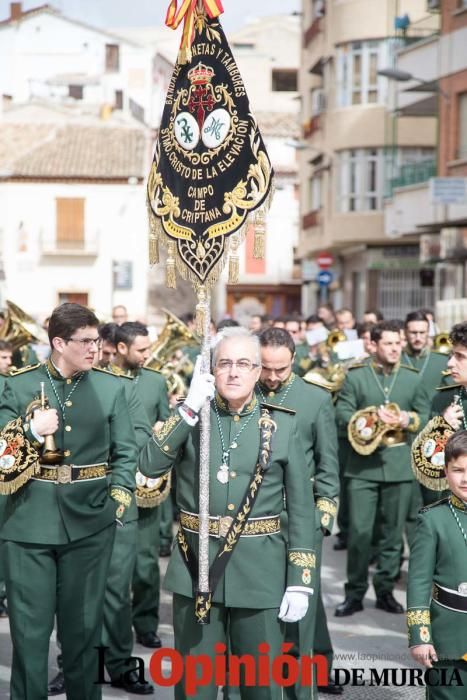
[345,478,412,600]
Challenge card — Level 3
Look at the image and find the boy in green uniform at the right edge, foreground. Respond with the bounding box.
[407,430,467,700]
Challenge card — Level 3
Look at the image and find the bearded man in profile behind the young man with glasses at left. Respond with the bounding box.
[110,322,170,649]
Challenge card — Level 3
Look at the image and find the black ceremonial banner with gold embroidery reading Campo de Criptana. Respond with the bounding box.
[148,0,273,302]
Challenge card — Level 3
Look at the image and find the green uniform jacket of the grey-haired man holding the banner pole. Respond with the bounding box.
[139,397,316,609]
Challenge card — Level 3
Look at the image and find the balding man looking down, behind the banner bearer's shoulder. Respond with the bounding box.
[257,328,342,700]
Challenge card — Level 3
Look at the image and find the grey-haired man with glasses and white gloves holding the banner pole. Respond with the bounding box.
[140,328,316,700]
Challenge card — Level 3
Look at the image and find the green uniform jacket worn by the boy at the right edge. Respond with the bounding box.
[407,496,467,660]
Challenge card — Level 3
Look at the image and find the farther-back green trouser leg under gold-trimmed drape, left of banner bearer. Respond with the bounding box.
[133,507,161,634]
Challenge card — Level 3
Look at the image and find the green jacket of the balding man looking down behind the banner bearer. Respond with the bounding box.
[258,373,339,535]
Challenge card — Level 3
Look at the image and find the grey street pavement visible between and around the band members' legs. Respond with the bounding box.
[0,537,425,700]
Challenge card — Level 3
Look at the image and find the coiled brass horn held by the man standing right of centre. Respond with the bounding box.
[347,403,404,456]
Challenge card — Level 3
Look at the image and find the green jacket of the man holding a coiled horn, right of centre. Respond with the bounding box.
[336,363,429,482]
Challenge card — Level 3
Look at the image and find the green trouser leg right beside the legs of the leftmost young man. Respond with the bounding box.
[101,520,138,680]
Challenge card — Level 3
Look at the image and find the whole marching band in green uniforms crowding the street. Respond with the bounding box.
[0,304,467,700]
